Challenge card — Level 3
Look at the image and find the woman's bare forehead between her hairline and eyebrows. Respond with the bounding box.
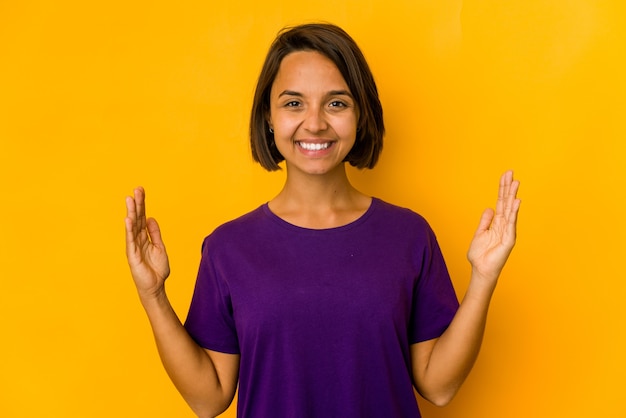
[272,51,347,89]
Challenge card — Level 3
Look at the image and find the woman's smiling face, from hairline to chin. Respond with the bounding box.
[268,51,358,174]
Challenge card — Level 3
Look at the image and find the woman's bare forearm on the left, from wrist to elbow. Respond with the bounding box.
[141,292,234,417]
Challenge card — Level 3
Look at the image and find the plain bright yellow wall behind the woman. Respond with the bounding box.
[0,0,626,418]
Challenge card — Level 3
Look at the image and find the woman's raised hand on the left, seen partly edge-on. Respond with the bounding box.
[125,187,170,298]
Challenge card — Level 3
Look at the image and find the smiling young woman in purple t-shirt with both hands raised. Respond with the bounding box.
[126,24,520,418]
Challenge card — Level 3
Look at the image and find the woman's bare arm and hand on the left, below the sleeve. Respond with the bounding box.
[125,188,239,417]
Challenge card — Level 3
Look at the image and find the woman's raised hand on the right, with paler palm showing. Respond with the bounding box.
[467,171,521,285]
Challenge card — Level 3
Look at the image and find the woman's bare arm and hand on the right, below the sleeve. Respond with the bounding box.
[411,171,520,405]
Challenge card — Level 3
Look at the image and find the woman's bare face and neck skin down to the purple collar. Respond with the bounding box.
[268,51,371,229]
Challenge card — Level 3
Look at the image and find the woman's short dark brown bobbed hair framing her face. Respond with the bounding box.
[250,23,385,171]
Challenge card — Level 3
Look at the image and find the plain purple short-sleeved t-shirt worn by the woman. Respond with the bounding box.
[185,198,458,418]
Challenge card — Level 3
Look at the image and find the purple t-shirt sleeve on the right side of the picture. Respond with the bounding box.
[409,227,459,344]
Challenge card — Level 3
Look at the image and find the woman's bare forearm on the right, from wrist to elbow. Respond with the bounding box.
[415,272,495,405]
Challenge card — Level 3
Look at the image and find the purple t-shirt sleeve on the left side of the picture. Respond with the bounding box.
[185,236,239,354]
